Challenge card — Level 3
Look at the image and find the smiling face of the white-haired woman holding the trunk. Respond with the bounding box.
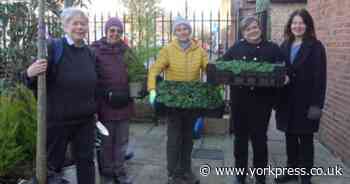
[64,16,89,43]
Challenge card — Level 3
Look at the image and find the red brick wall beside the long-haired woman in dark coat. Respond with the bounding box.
[308,0,350,164]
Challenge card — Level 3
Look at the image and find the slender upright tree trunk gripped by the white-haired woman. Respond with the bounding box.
[36,0,47,184]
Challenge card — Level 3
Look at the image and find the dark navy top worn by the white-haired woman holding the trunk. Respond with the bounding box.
[23,38,97,126]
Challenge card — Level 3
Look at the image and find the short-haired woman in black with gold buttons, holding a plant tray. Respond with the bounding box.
[222,17,283,184]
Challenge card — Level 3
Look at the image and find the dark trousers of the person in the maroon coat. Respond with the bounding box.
[98,121,129,177]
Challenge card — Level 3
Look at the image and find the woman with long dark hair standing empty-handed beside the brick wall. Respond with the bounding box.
[276,9,326,184]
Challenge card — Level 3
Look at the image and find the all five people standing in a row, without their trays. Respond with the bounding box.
[23,8,326,184]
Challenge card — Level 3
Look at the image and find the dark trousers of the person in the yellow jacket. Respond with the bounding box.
[167,111,197,176]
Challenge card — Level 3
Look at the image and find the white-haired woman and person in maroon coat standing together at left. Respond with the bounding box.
[23,8,135,184]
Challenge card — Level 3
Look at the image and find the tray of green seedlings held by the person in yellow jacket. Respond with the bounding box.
[155,80,225,118]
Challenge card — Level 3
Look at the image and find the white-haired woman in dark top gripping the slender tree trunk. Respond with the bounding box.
[23,8,97,184]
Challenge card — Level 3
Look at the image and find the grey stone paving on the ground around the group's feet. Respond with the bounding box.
[61,114,350,184]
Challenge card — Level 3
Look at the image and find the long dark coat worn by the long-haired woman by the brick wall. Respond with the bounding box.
[276,40,327,134]
